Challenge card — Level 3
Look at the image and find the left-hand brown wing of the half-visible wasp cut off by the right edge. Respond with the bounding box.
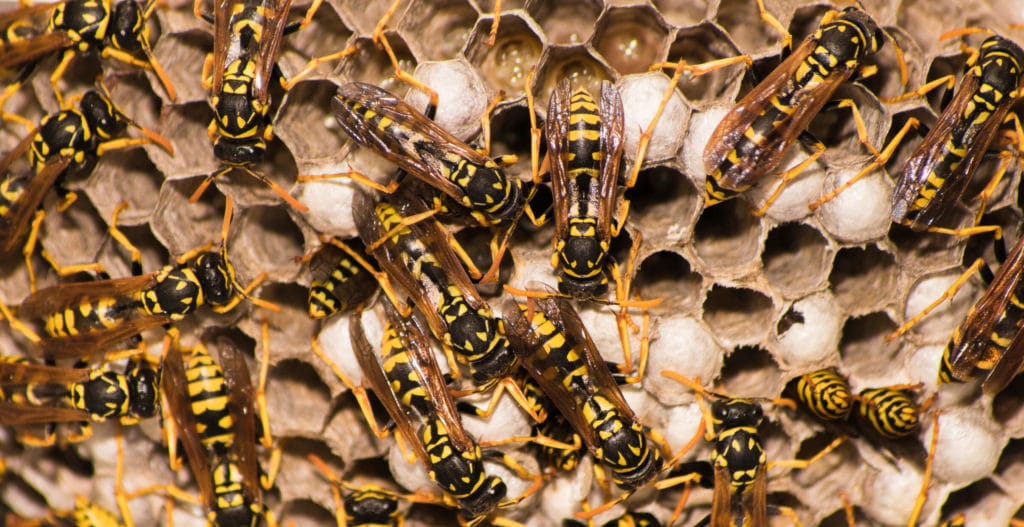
[937,236,1024,379]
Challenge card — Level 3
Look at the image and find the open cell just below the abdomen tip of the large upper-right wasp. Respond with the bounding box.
[693,200,762,275]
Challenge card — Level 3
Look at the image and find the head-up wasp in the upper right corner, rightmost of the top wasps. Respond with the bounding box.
[892,35,1024,230]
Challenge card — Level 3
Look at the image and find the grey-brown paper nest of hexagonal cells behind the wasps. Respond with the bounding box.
[0,0,1024,526]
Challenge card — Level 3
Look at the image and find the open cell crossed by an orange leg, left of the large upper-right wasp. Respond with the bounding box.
[668,24,745,101]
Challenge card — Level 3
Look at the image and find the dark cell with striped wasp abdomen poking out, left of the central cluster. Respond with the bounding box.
[306,238,378,319]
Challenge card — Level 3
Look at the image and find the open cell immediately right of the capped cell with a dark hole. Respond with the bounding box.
[839,311,900,378]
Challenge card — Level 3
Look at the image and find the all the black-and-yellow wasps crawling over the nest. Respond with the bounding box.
[0,0,1024,527]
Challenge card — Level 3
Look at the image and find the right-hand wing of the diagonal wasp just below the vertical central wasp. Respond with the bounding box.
[538,297,637,422]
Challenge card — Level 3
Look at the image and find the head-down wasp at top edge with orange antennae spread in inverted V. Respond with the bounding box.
[188,0,354,212]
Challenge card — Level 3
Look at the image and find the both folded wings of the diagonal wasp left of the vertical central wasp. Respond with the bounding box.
[334,82,494,200]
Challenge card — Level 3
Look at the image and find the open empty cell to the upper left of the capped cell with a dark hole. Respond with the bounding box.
[703,284,775,346]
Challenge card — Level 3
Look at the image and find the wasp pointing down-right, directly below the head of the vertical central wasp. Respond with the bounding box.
[503,298,664,491]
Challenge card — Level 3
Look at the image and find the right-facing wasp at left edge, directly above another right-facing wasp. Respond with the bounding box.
[0,199,276,358]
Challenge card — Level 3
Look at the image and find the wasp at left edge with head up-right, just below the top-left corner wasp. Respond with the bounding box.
[0,83,173,290]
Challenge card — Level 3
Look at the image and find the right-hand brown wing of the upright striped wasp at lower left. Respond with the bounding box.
[217,338,262,503]
